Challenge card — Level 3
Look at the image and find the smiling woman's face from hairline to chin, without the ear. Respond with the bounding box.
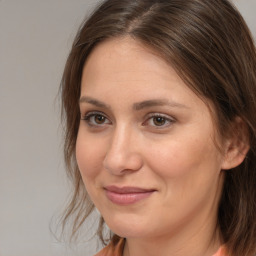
[76,37,224,238]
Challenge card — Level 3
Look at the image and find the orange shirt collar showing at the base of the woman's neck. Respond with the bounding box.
[95,239,226,256]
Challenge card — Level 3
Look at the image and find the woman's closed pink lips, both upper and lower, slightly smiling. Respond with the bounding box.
[104,186,156,205]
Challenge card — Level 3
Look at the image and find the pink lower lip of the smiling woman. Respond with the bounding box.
[106,190,154,205]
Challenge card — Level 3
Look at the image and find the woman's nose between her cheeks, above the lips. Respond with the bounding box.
[103,127,143,175]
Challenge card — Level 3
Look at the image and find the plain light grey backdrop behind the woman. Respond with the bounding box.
[0,0,256,256]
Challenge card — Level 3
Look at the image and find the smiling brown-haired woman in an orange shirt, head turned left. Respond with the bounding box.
[61,0,256,256]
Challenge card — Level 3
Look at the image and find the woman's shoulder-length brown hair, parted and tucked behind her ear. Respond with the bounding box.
[61,0,256,256]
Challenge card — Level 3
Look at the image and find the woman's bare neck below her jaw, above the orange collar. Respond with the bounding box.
[123,200,221,256]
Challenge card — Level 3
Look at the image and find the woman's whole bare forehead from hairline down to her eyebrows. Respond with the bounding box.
[81,37,213,108]
